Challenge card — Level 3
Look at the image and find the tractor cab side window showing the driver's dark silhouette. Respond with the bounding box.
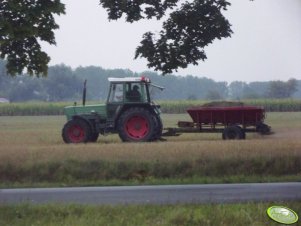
[126,82,147,102]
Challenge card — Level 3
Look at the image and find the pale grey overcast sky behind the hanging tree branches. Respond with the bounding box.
[43,0,301,82]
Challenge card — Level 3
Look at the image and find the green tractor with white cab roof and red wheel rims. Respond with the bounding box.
[62,77,163,143]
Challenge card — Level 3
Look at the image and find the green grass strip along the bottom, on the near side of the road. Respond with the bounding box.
[0,202,301,226]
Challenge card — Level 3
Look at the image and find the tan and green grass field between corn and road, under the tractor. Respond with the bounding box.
[0,112,301,187]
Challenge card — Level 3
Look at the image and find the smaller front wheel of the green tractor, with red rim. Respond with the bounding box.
[62,119,91,144]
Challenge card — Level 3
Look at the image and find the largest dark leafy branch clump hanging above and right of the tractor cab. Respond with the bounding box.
[135,0,232,74]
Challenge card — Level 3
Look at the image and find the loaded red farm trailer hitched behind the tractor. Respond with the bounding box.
[163,106,270,140]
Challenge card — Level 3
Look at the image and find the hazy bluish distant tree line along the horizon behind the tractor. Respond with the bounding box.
[0,61,301,102]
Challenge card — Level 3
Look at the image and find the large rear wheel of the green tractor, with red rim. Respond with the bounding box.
[117,107,156,142]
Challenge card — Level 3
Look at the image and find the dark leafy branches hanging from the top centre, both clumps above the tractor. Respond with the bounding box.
[100,0,232,74]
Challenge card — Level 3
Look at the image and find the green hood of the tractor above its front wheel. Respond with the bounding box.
[64,104,107,121]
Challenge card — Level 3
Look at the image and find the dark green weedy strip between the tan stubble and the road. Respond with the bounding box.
[0,153,301,186]
